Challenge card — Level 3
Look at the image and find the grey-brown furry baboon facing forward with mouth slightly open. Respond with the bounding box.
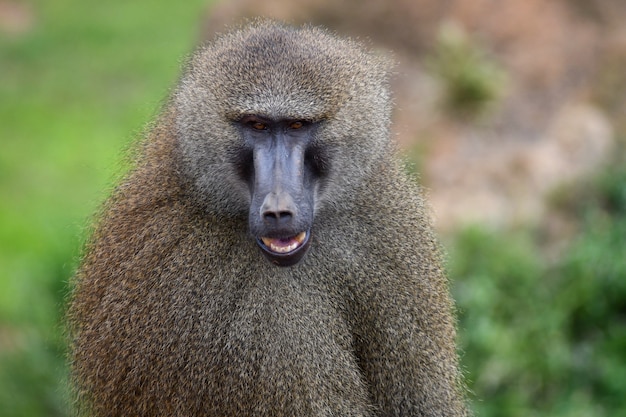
[69,21,466,417]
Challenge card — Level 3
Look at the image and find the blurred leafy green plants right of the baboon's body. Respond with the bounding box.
[450,154,626,417]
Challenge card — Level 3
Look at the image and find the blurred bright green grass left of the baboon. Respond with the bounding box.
[0,0,208,417]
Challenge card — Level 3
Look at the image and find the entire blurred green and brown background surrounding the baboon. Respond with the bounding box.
[0,0,626,417]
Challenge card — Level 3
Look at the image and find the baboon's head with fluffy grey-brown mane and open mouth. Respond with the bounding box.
[173,22,390,266]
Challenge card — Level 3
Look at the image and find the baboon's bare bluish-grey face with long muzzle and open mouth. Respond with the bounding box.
[235,114,328,266]
